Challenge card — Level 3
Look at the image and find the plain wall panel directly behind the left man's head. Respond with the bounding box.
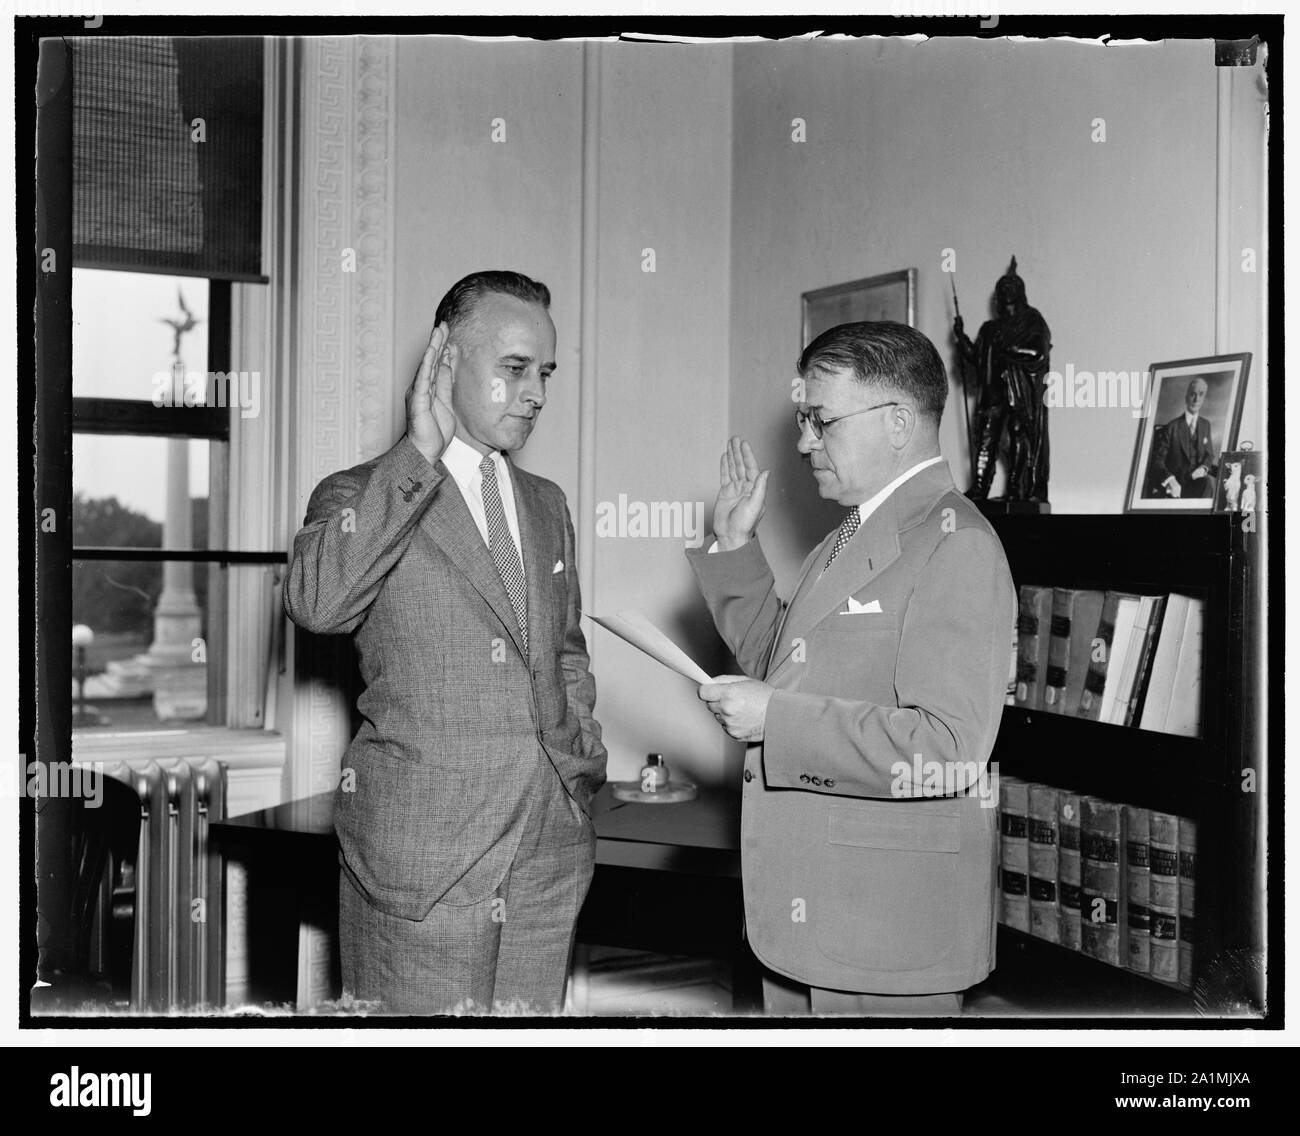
[393,36,582,502]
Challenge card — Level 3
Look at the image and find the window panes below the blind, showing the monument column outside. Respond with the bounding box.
[72,269,245,730]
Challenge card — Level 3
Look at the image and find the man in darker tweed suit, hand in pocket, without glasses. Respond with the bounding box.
[285,272,606,1013]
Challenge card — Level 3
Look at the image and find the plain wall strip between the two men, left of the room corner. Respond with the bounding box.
[584,44,741,782]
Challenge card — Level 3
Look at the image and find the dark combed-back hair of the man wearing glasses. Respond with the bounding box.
[798,320,948,422]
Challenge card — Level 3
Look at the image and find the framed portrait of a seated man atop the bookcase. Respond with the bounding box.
[1125,352,1251,513]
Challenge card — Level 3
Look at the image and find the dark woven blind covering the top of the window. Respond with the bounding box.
[70,36,264,281]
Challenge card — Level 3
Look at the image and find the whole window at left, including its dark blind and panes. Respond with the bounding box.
[64,36,285,733]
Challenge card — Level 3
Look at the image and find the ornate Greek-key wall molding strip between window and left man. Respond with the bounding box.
[285,36,397,1009]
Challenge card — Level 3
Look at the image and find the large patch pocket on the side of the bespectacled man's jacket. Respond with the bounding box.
[809,801,962,971]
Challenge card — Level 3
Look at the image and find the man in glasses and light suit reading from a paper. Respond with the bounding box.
[688,322,1015,1016]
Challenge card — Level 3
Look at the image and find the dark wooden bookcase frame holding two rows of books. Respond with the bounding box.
[991,515,1265,1018]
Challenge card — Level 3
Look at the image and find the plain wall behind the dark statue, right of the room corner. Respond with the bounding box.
[731,40,1262,582]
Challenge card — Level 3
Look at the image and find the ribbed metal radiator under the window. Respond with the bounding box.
[100,758,226,1013]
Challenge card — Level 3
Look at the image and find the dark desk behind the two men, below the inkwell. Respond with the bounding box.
[212,785,758,1009]
